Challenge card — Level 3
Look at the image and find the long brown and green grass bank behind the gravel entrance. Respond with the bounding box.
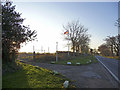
[20,54,98,65]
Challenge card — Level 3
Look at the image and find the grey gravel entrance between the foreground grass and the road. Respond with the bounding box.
[24,62,118,88]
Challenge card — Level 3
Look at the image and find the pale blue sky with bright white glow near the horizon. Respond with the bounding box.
[13,2,118,53]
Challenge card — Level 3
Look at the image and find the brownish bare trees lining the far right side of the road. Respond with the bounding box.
[98,34,120,56]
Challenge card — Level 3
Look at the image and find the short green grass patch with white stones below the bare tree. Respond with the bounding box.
[56,55,98,65]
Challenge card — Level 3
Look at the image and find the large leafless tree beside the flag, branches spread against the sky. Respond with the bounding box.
[63,20,90,55]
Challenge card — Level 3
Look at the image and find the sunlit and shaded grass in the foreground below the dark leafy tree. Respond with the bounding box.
[2,62,74,88]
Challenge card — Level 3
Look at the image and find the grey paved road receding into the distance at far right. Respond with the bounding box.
[95,56,120,83]
